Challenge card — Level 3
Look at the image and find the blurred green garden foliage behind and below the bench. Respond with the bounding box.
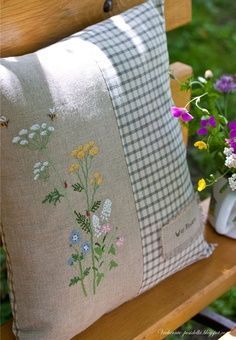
[0,0,236,339]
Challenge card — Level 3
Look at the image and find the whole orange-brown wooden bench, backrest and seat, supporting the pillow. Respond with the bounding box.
[1,0,236,340]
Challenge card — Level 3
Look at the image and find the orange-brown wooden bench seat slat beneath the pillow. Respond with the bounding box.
[2,202,236,340]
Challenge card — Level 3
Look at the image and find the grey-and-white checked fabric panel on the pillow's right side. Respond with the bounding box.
[78,1,214,292]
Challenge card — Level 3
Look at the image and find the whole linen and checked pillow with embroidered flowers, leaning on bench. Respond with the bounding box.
[0,2,215,340]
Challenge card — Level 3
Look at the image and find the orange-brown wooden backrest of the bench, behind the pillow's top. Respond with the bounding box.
[0,0,191,57]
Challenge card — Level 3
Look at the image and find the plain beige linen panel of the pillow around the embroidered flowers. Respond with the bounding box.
[1,41,143,340]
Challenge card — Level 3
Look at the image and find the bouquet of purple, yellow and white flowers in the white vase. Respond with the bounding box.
[171,70,236,191]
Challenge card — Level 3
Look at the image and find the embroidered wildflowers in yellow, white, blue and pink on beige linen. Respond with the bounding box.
[12,130,124,297]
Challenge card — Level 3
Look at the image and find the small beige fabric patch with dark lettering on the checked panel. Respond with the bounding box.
[161,199,202,258]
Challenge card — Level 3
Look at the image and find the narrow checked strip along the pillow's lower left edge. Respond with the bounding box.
[0,223,19,339]
